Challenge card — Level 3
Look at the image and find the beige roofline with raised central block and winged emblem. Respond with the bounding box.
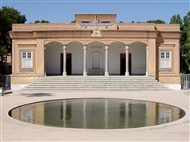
[10,14,182,42]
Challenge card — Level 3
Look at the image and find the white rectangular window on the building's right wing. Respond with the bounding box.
[160,51,171,68]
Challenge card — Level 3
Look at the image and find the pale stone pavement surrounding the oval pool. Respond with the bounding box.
[0,91,190,142]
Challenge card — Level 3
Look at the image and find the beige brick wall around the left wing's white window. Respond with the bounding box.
[12,39,44,84]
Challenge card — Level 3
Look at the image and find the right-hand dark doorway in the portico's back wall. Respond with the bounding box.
[120,53,131,75]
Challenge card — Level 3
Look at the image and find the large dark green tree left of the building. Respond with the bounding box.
[0,6,26,74]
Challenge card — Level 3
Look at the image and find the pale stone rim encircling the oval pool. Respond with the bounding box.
[6,97,190,131]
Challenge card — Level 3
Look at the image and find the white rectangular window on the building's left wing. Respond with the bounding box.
[21,51,33,68]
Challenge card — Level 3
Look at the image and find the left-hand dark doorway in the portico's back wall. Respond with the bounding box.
[60,53,72,75]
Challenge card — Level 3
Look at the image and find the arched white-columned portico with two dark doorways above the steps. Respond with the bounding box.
[44,41,148,76]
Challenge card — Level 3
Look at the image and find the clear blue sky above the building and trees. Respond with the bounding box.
[0,0,190,23]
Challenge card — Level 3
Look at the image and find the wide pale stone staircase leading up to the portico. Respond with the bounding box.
[23,76,169,92]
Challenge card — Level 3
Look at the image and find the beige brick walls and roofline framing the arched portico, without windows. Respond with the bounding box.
[10,18,181,84]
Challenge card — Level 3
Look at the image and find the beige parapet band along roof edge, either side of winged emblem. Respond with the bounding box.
[12,23,180,31]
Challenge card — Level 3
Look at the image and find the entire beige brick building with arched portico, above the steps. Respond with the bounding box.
[10,14,182,89]
